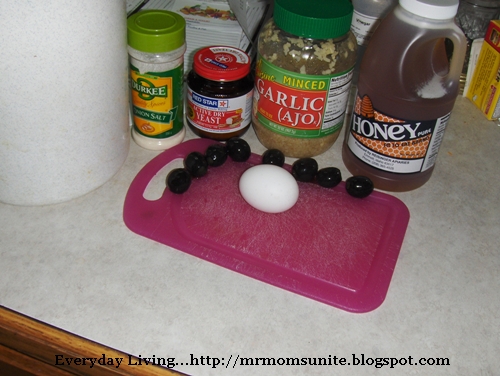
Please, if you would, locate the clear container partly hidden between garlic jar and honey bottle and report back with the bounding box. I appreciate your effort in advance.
[351,0,398,84]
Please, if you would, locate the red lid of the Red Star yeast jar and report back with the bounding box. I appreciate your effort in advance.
[193,46,250,81]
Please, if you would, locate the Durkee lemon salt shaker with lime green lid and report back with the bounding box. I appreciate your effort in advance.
[128,10,186,150]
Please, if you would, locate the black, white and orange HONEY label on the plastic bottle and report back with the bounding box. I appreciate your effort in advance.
[347,96,450,174]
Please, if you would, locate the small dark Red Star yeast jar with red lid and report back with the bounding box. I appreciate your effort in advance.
[185,46,253,141]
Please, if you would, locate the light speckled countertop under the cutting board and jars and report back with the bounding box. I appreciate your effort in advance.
[0,97,500,376]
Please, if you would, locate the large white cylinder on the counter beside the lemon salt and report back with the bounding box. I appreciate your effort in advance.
[0,0,130,205]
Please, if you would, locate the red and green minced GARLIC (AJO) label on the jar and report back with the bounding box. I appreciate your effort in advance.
[254,57,352,138]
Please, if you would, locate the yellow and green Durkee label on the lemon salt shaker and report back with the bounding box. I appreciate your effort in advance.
[130,67,183,137]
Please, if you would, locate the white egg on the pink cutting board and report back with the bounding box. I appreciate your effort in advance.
[239,164,299,213]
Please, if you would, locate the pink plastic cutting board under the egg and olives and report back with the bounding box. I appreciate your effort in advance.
[123,139,410,313]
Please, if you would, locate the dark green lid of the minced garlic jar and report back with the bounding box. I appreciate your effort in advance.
[273,0,353,39]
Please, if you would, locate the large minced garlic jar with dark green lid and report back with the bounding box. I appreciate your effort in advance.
[252,0,357,158]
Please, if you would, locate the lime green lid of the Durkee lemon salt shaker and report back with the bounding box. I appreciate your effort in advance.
[127,10,186,53]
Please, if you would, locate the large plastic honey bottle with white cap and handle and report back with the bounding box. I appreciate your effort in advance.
[342,0,466,191]
